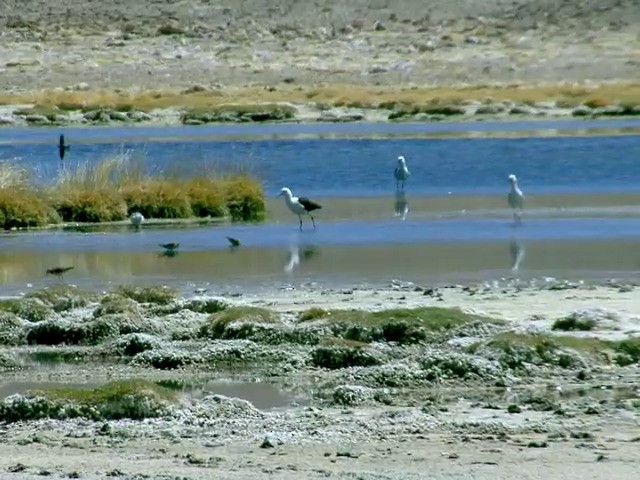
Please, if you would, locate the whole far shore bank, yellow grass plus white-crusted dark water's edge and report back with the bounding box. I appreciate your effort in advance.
[0,83,640,126]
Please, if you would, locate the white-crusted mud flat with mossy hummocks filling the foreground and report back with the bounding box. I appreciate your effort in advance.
[0,279,640,479]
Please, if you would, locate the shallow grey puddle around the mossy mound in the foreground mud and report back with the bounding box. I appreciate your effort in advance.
[0,380,304,410]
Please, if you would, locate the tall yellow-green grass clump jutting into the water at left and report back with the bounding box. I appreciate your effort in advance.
[0,154,265,229]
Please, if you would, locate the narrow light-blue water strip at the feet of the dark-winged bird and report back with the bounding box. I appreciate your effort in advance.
[0,218,640,253]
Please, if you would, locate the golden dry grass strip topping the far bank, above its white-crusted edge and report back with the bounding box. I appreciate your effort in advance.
[0,83,640,114]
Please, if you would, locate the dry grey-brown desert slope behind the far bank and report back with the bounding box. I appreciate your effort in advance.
[0,0,640,90]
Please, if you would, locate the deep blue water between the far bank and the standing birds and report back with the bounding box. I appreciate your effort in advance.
[0,121,640,198]
